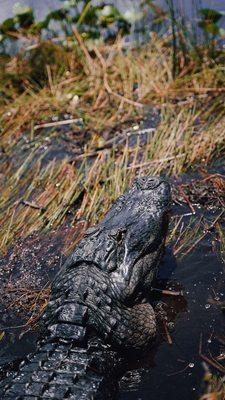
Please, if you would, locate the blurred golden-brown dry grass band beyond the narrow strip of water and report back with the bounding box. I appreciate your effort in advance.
[0,33,225,148]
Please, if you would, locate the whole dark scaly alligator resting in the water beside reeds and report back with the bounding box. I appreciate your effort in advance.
[1,176,171,400]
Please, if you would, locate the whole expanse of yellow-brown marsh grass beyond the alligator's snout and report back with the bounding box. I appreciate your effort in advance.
[0,31,225,252]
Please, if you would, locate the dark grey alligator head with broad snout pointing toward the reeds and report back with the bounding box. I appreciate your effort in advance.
[74,176,171,299]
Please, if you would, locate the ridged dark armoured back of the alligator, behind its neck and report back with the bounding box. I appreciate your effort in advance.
[0,267,117,400]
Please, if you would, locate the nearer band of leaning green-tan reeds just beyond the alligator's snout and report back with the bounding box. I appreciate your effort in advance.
[0,105,222,251]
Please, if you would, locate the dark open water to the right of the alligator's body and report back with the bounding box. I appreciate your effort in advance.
[119,227,225,400]
